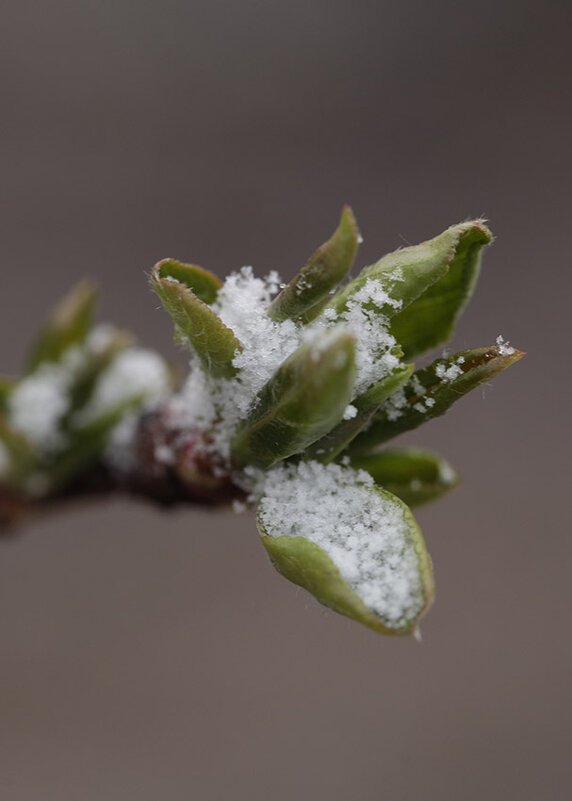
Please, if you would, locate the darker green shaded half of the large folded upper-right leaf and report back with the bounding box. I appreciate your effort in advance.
[391,223,492,359]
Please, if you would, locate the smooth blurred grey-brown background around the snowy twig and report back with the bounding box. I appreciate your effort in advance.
[0,0,572,801]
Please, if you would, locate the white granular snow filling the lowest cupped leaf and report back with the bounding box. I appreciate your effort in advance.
[260,462,425,627]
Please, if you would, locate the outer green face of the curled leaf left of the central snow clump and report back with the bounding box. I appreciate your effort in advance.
[151,262,242,378]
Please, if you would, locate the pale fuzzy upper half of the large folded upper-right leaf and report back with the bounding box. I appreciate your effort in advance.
[329,220,490,328]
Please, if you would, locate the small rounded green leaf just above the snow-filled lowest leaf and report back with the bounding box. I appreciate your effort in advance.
[351,448,459,506]
